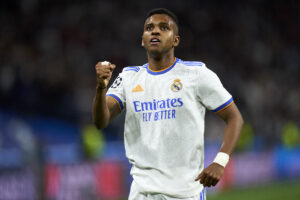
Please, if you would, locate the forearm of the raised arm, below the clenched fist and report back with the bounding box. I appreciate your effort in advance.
[93,88,110,129]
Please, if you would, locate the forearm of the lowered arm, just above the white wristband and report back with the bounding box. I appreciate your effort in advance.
[220,115,243,155]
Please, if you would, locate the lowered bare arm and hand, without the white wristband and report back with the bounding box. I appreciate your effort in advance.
[195,103,243,187]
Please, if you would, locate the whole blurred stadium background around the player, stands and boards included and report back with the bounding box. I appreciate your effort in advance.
[0,0,300,200]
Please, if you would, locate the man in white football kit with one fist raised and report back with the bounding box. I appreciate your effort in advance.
[93,9,243,200]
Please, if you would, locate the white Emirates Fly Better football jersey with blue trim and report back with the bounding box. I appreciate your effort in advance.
[107,58,233,198]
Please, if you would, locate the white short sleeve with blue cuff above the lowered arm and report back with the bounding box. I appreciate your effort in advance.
[197,66,233,112]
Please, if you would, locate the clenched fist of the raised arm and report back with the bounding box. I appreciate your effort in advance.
[95,62,116,88]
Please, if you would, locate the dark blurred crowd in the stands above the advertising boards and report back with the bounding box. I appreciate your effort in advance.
[0,0,300,145]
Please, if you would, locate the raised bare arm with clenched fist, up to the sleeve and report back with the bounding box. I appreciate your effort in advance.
[93,62,121,129]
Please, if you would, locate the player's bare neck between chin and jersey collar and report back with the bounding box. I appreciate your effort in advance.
[147,51,175,71]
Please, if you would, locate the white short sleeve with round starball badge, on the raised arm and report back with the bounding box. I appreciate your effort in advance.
[106,73,126,111]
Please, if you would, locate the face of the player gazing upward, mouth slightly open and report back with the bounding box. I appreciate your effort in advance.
[142,14,179,54]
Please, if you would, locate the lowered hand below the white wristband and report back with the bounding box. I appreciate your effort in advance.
[195,163,224,187]
